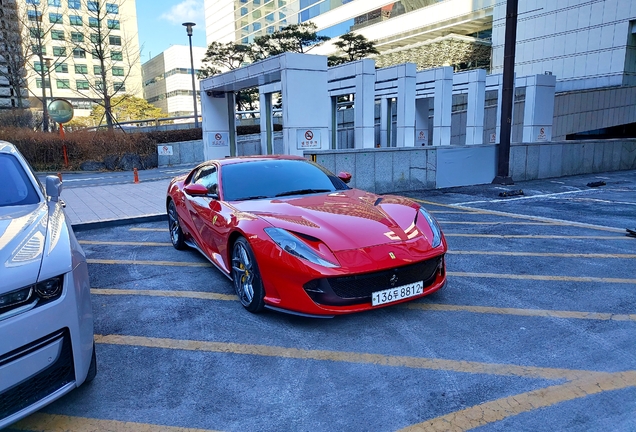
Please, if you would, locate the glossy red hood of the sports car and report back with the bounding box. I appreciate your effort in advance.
[233,189,421,252]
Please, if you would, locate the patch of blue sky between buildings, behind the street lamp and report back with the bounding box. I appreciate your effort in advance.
[136,0,206,63]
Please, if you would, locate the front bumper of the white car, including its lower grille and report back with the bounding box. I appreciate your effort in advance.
[0,262,93,429]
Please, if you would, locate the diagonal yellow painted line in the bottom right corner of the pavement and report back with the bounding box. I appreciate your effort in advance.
[401,371,636,432]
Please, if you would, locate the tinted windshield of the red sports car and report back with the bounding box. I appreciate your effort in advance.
[221,159,349,201]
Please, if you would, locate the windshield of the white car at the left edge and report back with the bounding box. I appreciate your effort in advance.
[0,154,40,207]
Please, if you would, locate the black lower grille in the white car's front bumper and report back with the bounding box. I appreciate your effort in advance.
[0,329,75,418]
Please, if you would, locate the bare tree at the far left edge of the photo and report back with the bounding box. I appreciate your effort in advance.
[0,0,27,108]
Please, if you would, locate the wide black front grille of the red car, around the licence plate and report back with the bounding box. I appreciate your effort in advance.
[304,255,444,306]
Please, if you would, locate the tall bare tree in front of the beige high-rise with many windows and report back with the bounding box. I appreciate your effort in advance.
[69,0,140,130]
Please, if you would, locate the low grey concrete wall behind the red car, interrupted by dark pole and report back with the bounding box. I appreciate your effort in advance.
[305,139,636,193]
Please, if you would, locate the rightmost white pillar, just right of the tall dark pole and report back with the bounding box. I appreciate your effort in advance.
[523,75,556,143]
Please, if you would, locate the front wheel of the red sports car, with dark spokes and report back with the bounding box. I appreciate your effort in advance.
[232,237,265,313]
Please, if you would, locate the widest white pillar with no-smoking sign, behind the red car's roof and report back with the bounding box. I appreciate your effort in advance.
[280,53,331,156]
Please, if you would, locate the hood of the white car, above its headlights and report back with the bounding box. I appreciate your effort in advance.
[0,202,49,294]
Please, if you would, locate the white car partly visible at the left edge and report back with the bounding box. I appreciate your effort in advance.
[0,141,97,429]
